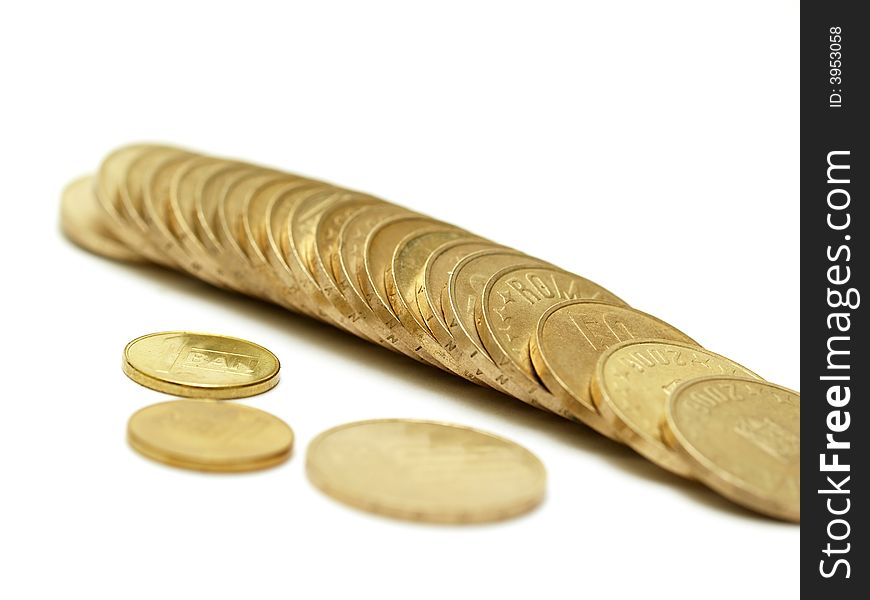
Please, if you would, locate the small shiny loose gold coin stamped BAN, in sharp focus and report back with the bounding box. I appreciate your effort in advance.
[123,331,281,400]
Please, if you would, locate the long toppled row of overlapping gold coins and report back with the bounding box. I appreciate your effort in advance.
[61,145,800,519]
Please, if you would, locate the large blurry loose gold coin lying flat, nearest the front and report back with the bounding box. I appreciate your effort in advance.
[306,419,546,523]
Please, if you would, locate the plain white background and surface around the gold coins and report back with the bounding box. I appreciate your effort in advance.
[0,0,800,599]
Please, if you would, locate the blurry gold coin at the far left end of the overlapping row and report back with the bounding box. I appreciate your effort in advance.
[60,177,143,262]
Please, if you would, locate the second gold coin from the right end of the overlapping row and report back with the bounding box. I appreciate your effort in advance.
[590,340,761,477]
